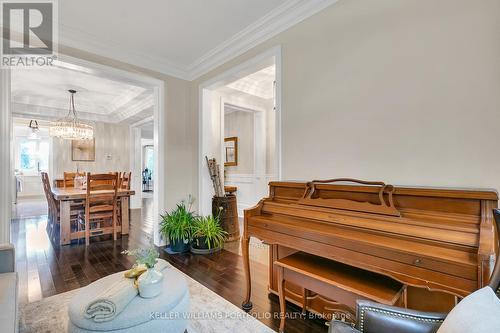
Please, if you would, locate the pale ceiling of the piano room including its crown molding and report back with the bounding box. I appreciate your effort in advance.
[58,0,336,80]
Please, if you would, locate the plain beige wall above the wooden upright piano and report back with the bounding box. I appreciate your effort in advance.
[192,0,500,195]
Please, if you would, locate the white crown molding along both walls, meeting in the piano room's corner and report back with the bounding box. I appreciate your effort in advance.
[55,0,338,81]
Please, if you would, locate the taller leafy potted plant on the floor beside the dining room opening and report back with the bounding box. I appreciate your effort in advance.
[160,196,194,253]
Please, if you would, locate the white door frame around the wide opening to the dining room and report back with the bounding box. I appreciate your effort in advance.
[0,54,167,246]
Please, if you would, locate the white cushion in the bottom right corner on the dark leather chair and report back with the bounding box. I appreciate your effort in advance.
[437,287,500,333]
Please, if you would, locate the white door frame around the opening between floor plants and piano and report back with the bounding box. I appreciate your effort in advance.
[198,45,283,214]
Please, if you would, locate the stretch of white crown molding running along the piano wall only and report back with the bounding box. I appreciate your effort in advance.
[187,0,338,80]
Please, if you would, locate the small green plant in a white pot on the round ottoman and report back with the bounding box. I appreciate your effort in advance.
[122,247,163,298]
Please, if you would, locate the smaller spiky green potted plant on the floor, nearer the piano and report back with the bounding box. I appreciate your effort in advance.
[191,215,227,254]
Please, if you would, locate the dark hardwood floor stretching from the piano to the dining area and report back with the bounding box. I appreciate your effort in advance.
[11,198,327,333]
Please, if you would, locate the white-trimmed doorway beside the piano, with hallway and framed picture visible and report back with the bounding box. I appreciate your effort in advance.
[199,47,282,217]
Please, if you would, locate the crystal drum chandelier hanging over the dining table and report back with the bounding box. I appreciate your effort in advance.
[49,90,94,140]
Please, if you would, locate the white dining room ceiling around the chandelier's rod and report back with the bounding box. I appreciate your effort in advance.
[11,67,154,124]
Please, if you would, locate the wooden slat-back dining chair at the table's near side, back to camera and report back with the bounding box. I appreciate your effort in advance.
[78,172,119,245]
